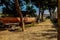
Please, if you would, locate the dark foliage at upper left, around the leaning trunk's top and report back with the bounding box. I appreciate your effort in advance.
[0,0,23,17]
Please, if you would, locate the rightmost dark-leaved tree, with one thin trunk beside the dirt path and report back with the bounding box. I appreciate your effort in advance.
[48,0,57,18]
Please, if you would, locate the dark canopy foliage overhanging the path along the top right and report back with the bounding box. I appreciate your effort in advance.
[31,0,57,9]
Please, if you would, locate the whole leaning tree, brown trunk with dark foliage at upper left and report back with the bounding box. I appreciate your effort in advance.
[0,0,24,31]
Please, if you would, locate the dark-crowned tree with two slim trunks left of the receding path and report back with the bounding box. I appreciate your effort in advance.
[31,0,48,21]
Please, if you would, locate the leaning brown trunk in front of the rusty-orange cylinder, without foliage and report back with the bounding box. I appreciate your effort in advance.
[14,0,24,31]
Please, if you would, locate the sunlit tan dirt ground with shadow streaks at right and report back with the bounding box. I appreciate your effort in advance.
[0,20,57,40]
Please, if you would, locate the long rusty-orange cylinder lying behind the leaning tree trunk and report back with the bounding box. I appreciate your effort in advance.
[0,17,36,24]
